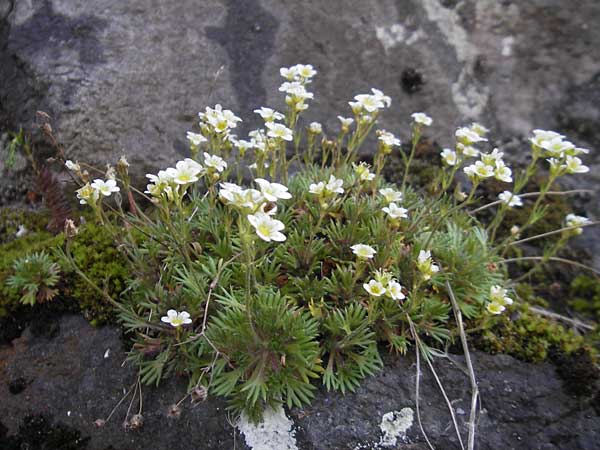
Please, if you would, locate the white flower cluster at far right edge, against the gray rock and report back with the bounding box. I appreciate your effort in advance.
[529,130,590,176]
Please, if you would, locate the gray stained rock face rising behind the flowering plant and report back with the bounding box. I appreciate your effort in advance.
[0,0,600,169]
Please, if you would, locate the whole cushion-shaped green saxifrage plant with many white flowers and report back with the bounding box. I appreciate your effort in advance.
[52,65,592,420]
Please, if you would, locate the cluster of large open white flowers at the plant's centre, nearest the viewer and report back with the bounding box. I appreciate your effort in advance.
[219,178,292,242]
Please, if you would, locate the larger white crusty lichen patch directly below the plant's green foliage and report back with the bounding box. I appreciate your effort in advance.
[237,406,298,450]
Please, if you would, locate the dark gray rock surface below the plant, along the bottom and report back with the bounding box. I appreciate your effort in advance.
[0,316,600,450]
